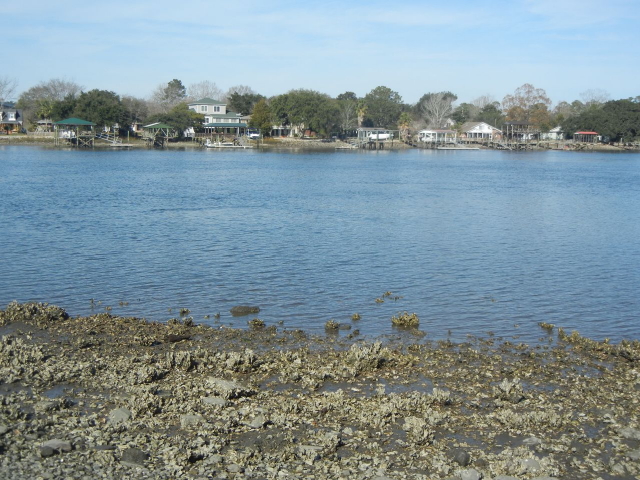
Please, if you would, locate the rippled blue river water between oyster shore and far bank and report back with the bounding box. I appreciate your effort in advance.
[0,147,640,341]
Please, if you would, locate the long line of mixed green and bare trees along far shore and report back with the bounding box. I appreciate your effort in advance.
[0,77,640,141]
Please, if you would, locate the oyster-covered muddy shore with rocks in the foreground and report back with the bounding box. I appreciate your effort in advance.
[0,303,640,480]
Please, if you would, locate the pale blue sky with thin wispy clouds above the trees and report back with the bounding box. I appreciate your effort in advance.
[0,0,640,104]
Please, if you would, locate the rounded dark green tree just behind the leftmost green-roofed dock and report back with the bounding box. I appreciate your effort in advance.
[73,89,129,128]
